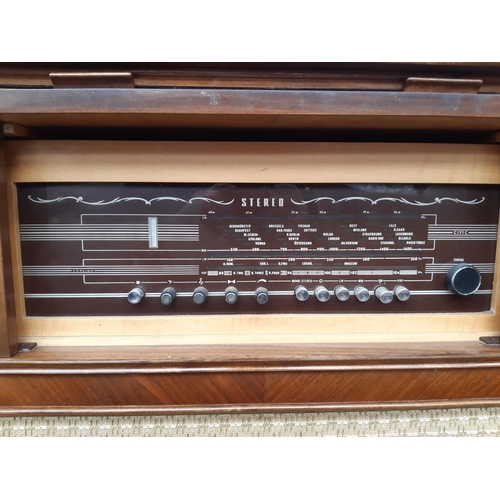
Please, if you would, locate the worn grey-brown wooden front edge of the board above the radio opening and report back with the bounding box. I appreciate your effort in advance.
[0,88,500,118]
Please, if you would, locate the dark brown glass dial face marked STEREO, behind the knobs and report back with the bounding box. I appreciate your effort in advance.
[17,183,499,316]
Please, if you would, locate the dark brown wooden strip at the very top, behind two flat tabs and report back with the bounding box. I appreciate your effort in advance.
[0,63,500,93]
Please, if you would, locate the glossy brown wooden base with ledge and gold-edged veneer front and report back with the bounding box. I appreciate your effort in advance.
[0,341,500,416]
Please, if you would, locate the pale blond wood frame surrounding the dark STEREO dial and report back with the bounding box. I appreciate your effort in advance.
[5,141,500,346]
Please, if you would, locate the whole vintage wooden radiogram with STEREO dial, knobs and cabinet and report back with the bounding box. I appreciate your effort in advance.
[0,63,500,415]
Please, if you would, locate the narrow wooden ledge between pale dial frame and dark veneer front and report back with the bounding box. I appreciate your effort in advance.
[0,340,500,367]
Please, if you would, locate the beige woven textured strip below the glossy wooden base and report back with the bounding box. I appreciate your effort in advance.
[0,408,500,437]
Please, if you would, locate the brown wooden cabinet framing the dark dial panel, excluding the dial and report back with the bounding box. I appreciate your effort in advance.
[0,64,500,415]
